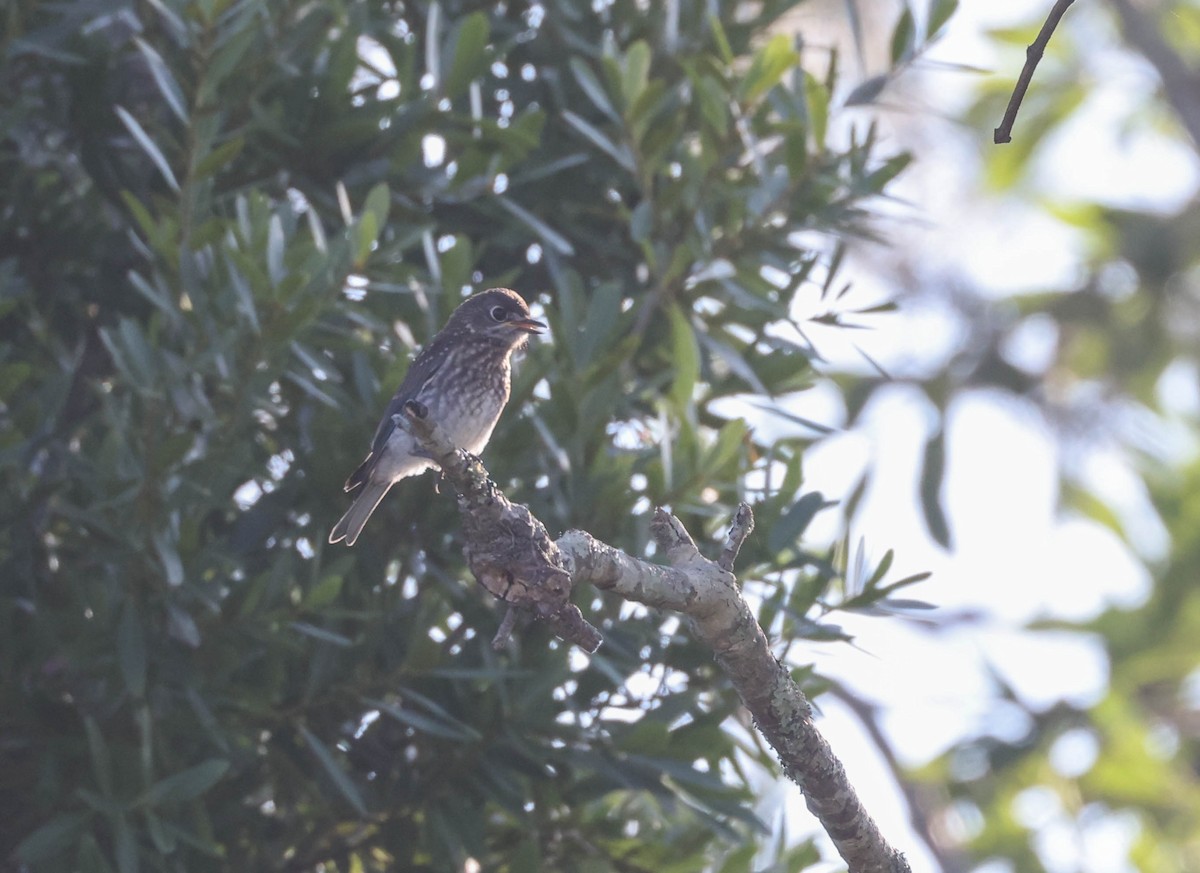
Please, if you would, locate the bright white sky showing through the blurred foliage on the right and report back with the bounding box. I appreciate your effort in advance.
[768,0,1200,873]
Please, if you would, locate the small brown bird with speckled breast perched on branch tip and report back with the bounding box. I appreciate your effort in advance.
[329,288,546,546]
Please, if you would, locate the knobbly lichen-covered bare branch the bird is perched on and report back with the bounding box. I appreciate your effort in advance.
[396,403,911,873]
